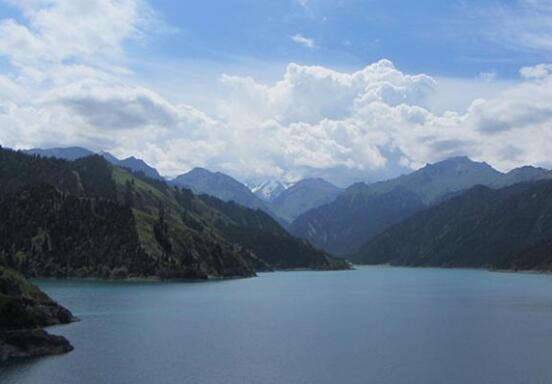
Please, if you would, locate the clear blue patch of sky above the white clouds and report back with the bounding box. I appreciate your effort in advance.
[123,0,552,109]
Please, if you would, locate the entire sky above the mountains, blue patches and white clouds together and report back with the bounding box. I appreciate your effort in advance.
[0,0,552,186]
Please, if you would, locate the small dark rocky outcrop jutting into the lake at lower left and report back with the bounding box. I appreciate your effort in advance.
[0,267,77,361]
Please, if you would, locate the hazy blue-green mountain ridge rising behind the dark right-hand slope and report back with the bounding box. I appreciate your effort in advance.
[289,157,550,256]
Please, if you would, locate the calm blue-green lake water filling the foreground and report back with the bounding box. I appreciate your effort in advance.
[0,268,552,384]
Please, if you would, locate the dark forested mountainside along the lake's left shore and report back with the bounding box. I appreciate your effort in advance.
[0,149,348,279]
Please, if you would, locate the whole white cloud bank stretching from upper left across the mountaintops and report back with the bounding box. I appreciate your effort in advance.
[0,0,552,185]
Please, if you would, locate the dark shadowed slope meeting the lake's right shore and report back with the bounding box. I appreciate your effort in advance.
[352,180,552,271]
